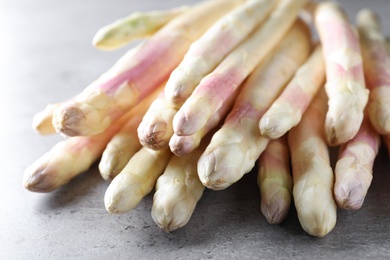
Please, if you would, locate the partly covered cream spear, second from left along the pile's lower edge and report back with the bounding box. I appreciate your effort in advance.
[99,86,163,181]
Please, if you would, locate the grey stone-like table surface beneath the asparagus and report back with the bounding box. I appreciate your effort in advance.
[0,0,390,259]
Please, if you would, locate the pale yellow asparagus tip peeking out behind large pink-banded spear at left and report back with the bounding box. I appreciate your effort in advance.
[32,103,60,135]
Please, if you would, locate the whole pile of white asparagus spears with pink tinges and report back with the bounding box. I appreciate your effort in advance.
[24,0,390,237]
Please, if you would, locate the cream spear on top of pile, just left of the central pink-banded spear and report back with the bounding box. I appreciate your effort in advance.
[165,0,278,106]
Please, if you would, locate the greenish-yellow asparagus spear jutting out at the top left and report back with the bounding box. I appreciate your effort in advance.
[92,6,189,50]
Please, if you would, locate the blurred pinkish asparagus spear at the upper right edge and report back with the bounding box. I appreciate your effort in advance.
[357,9,390,135]
